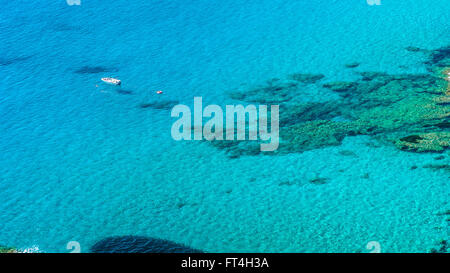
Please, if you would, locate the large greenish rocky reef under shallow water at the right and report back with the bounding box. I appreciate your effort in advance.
[211,43,450,158]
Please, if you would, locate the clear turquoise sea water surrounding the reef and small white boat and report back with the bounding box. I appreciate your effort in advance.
[0,0,450,252]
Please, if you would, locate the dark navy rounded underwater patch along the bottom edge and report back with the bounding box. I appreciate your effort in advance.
[91,236,203,253]
